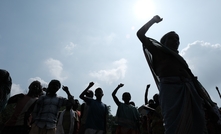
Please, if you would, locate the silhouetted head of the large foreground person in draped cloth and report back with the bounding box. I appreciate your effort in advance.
[160,31,180,52]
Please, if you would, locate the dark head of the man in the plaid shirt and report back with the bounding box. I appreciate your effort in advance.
[47,80,61,95]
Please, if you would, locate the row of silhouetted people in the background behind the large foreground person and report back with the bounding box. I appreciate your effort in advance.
[0,72,220,134]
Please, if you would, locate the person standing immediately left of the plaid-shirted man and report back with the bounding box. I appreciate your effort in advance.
[2,81,42,134]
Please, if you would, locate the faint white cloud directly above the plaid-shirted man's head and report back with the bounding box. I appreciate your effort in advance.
[45,58,67,82]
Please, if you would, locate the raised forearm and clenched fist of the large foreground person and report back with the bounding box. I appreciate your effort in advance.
[137,15,163,43]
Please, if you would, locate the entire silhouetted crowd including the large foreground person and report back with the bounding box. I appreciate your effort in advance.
[0,15,221,134]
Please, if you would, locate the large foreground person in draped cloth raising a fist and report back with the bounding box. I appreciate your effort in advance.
[137,15,221,134]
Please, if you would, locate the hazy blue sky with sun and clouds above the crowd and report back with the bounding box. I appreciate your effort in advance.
[0,0,221,115]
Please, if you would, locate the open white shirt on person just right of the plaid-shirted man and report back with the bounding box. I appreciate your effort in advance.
[56,109,75,134]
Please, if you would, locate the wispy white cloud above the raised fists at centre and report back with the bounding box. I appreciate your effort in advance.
[90,59,127,83]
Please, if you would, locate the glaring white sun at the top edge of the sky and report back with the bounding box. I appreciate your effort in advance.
[134,0,155,20]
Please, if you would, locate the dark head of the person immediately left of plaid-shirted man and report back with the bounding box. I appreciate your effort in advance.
[28,80,43,97]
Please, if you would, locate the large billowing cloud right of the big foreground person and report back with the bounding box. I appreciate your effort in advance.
[181,41,221,90]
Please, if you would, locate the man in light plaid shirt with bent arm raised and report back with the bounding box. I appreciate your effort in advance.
[30,80,74,134]
